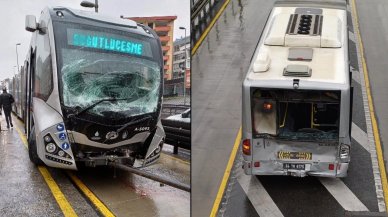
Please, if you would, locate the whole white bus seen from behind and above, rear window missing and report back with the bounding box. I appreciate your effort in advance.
[242,1,352,177]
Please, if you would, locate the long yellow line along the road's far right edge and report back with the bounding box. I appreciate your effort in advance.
[352,0,388,207]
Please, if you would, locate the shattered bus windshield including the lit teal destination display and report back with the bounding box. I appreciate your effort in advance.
[57,22,161,116]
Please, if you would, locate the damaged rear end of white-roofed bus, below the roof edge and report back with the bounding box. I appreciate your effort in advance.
[242,87,350,177]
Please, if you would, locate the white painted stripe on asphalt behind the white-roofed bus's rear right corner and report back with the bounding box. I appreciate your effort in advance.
[319,177,369,211]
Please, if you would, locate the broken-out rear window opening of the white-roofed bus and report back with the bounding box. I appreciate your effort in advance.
[252,90,340,141]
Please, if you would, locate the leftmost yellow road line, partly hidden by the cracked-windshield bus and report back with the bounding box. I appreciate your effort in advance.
[15,125,77,217]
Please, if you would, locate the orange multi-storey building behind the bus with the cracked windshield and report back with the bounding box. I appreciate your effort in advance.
[121,16,177,81]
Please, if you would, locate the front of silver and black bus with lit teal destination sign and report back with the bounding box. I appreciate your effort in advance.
[25,7,165,169]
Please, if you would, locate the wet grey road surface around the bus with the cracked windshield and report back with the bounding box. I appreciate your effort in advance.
[0,116,190,217]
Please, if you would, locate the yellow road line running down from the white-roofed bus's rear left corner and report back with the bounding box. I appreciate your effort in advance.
[210,127,241,217]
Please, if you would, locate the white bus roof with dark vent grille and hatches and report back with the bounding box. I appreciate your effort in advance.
[246,2,349,84]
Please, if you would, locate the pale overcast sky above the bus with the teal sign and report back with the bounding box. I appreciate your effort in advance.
[0,0,190,81]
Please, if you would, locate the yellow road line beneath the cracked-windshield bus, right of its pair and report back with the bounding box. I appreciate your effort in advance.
[67,171,115,217]
